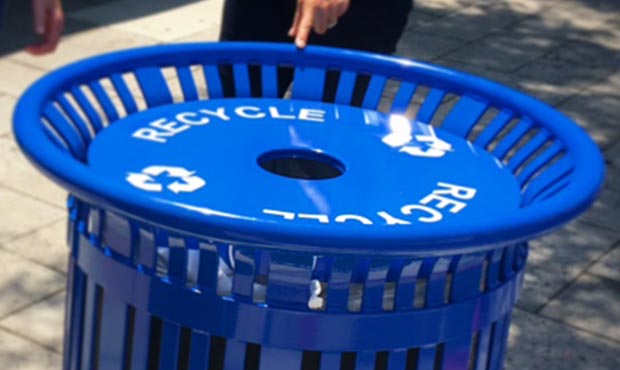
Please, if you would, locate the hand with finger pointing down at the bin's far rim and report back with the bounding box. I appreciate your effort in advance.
[288,0,350,48]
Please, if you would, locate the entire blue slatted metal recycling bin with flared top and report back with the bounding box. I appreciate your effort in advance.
[14,43,604,370]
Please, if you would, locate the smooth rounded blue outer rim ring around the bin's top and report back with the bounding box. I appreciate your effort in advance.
[14,43,604,255]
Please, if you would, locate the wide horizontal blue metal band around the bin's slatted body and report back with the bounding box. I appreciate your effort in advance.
[78,233,522,351]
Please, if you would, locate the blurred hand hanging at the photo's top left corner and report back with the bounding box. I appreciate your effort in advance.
[26,0,65,55]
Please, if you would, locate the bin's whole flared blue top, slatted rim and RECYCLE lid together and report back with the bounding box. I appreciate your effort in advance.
[14,43,604,255]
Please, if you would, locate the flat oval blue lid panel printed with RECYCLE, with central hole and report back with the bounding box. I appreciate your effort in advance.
[88,99,521,234]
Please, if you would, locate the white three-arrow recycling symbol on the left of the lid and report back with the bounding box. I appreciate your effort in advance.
[126,166,207,194]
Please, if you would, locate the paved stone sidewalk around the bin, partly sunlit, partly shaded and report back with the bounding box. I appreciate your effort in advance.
[0,0,620,370]
